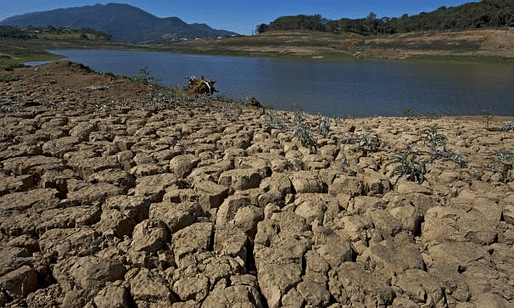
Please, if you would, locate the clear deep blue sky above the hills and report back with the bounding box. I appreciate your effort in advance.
[0,0,479,34]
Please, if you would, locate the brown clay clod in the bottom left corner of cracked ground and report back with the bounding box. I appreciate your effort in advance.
[0,265,39,298]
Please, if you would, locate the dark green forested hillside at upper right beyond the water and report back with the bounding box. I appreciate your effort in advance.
[256,0,514,35]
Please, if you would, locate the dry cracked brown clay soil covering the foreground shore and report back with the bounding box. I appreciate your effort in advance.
[0,62,514,308]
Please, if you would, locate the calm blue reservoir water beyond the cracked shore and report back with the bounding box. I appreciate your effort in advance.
[51,50,514,116]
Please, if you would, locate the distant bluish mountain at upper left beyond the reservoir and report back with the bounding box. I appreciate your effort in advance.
[0,3,239,44]
